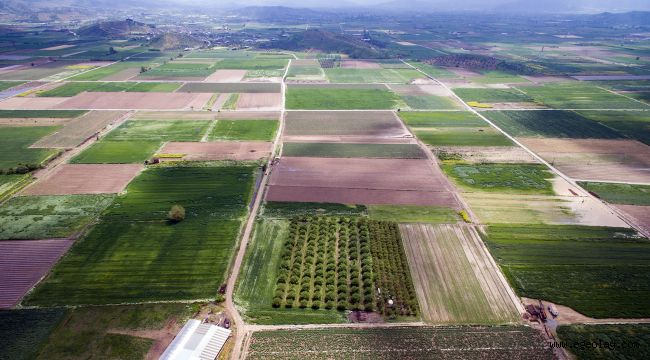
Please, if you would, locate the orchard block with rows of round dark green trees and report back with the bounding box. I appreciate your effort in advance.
[273,217,417,316]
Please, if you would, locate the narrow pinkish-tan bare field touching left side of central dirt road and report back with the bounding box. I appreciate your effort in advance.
[160,141,273,161]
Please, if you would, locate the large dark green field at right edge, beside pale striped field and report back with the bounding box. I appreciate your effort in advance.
[485,225,650,318]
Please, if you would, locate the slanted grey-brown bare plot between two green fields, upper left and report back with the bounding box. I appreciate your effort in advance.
[31,111,127,149]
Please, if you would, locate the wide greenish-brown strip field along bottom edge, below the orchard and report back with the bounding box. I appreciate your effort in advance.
[247,326,555,360]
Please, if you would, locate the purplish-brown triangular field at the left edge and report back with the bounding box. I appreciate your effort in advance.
[0,239,74,309]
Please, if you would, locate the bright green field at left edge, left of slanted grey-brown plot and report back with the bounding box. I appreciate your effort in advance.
[0,126,60,171]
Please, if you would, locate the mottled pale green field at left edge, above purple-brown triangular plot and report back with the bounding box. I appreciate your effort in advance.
[0,194,114,240]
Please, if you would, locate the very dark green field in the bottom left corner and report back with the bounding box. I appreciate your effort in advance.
[0,309,66,360]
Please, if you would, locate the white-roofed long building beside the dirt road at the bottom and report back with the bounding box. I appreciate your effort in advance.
[160,320,231,360]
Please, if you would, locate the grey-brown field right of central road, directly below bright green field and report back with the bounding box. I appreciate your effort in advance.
[284,111,411,137]
